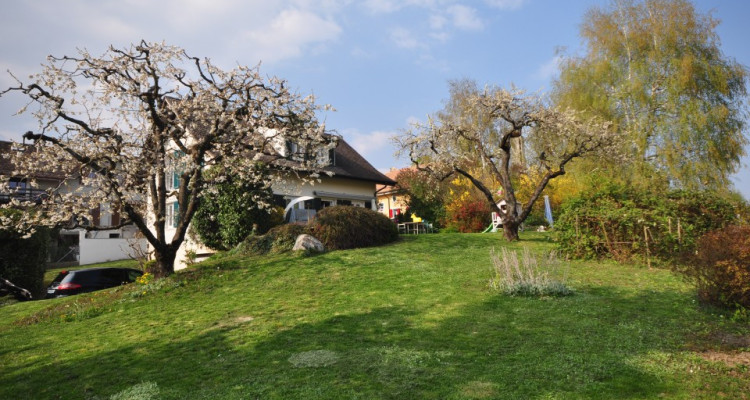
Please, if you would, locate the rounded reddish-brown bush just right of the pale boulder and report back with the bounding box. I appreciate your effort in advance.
[310,206,398,250]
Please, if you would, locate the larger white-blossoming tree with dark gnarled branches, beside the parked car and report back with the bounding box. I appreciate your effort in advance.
[0,41,331,275]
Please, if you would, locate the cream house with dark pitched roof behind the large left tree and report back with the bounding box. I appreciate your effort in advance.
[166,138,396,269]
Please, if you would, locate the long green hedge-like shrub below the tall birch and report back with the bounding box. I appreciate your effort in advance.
[555,182,737,262]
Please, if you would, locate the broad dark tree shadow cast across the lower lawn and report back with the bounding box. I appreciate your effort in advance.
[0,288,704,399]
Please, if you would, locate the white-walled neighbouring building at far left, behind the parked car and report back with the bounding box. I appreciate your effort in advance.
[0,141,147,265]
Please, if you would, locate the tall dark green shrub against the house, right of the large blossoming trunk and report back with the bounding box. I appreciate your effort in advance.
[191,168,283,250]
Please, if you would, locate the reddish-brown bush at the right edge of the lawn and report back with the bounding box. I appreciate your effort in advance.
[676,226,750,308]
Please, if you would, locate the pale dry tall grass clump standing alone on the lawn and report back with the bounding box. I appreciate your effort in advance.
[490,247,573,297]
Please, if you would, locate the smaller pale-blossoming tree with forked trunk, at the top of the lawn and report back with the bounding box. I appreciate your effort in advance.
[396,80,620,240]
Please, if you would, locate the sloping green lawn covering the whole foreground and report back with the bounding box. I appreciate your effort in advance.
[0,233,750,399]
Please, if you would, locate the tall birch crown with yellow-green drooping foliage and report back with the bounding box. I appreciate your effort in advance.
[555,0,748,189]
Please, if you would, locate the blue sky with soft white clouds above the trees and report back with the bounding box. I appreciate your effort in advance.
[0,0,750,199]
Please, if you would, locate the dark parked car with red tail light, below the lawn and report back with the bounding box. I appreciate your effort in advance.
[46,268,143,299]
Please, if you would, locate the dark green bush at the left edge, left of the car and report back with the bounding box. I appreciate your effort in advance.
[0,222,50,299]
